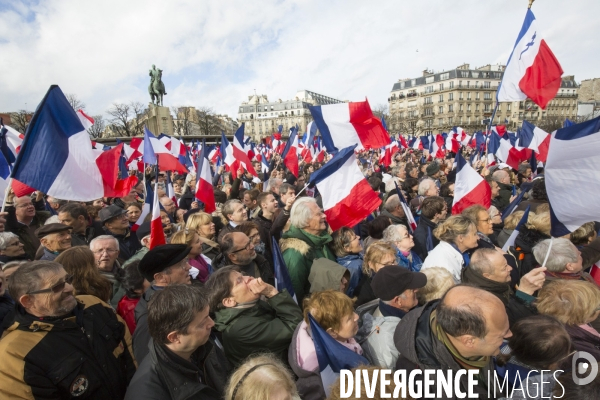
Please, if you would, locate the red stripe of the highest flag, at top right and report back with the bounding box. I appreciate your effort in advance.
[519,39,563,110]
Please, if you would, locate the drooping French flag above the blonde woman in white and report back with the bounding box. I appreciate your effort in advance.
[452,153,492,214]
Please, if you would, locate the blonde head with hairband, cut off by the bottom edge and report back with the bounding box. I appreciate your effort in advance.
[225,354,300,400]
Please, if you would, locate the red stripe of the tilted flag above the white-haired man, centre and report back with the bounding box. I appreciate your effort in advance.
[325,179,381,231]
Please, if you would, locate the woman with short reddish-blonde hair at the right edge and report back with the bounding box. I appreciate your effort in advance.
[536,279,600,360]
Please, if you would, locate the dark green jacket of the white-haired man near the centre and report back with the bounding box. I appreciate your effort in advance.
[280,225,335,304]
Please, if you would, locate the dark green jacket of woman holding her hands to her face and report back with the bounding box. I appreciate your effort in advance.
[215,291,302,366]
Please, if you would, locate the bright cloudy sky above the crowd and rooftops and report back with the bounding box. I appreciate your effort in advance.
[0,0,600,118]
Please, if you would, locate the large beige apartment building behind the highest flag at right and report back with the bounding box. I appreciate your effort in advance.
[387,64,578,135]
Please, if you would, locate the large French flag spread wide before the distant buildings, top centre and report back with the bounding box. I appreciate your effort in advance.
[309,100,390,153]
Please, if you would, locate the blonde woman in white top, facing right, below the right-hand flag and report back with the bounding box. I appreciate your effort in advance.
[421,215,478,283]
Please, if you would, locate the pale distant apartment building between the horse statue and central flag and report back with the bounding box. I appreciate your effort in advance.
[238,90,343,142]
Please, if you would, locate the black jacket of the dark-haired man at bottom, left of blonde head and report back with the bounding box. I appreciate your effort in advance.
[125,339,231,400]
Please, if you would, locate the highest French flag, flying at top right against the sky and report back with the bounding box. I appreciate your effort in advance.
[496,9,563,109]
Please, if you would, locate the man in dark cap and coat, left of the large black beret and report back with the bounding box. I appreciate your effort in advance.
[98,204,142,261]
